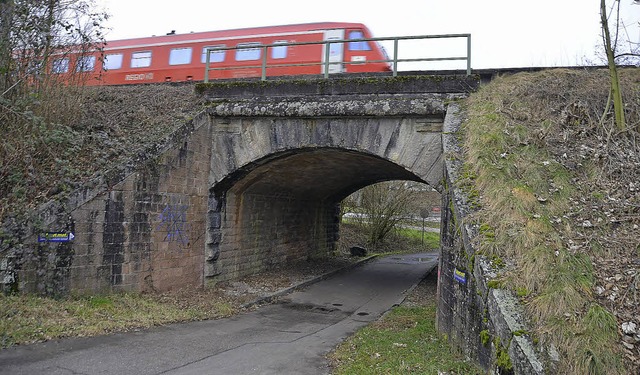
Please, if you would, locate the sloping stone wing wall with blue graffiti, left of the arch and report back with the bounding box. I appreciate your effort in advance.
[0,116,211,295]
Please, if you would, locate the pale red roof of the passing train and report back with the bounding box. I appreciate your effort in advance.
[105,22,366,50]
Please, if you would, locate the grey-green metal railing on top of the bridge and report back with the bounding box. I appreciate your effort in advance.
[204,34,471,82]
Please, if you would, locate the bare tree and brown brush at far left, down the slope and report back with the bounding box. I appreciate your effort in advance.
[0,0,106,221]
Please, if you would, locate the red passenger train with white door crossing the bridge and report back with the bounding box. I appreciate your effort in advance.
[51,22,391,85]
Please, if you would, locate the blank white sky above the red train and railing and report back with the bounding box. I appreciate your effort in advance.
[97,0,640,69]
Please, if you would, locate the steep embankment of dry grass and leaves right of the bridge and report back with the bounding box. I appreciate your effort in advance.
[460,70,640,374]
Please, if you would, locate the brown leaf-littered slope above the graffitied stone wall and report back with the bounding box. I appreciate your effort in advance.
[0,84,203,223]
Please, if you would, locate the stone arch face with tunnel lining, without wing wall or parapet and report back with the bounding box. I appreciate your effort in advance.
[204,106,443,283]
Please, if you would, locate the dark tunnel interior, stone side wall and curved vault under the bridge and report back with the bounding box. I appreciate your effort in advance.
[205,148,437,282]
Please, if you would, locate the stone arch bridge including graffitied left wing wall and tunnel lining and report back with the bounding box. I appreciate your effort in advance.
[0,75,478,293]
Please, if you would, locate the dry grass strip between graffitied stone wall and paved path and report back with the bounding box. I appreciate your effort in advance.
[0,292,235,348]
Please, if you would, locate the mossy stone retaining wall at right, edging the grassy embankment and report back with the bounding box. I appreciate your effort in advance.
[437,105,550,374]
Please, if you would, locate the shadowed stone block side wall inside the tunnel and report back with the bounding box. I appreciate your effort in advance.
[205,193,337,284]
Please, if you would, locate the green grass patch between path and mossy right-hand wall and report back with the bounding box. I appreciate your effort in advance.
[330,305,484,375]
